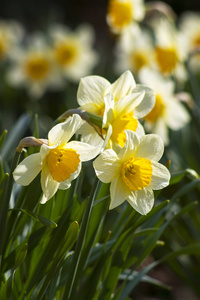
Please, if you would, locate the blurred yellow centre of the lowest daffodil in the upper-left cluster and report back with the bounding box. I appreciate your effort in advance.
[25,54,50,80]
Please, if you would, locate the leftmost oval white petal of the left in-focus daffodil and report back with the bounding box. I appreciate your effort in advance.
[13,153,42,186]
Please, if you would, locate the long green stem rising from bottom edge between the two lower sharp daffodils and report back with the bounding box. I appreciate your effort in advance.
[63,177,99,300]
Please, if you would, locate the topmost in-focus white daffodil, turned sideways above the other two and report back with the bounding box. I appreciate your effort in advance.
[77,71,155,148]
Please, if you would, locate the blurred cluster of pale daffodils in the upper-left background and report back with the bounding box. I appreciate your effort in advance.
[0,20,98,99]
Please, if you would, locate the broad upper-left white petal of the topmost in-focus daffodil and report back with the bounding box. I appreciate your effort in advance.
[77,76,110,105]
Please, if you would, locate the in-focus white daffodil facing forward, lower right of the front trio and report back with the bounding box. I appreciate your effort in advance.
[93,130,170,215]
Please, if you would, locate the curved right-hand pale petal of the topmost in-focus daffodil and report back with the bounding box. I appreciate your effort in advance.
[134,85,155,119]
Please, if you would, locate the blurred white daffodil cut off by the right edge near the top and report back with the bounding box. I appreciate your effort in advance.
[180,12,200,72]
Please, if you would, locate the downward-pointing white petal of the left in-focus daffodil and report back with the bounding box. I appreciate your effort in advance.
[40,166,59,203]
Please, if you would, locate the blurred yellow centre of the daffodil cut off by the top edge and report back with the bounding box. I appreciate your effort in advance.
[108,0,132,28]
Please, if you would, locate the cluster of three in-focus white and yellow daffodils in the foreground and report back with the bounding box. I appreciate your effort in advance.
[13,71,170,214]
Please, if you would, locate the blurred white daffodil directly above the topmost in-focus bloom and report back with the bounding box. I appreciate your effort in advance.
[115,25,155,74]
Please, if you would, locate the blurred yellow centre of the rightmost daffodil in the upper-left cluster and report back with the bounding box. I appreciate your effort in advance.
[55,41,77,66]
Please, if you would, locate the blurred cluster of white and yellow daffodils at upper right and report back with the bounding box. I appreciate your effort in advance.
[107,0,200,145]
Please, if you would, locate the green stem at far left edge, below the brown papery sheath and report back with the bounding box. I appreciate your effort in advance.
[0,151,21,272]
